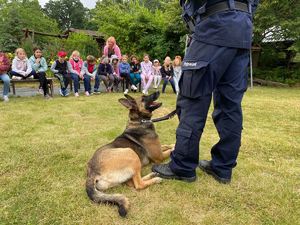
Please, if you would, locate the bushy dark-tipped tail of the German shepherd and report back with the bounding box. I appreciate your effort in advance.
[86,177,129,217]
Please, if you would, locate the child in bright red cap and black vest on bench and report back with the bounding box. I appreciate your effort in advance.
[50,51,73,96]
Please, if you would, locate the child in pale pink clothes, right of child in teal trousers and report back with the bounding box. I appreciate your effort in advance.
[141,54,153,94]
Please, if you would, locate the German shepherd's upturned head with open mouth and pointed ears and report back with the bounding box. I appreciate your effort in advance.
[119,91,162,119]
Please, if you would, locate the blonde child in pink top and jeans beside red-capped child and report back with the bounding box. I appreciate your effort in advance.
[69,50,83,97]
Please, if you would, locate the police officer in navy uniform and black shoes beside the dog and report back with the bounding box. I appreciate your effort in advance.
[152,0,258,183]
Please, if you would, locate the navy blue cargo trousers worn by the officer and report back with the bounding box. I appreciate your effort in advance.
[169,40,249,178]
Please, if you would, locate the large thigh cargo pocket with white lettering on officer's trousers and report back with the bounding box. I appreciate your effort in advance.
[179,61,208,98]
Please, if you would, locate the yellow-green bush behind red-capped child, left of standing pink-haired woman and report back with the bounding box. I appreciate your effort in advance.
[64,33,100,59]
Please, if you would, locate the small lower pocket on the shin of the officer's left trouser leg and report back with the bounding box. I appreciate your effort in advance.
[176,128,192,155]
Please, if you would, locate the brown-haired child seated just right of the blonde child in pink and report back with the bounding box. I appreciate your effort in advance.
[81,55,100,96]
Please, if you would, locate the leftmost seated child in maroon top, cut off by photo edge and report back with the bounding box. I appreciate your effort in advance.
[0,52,10,102]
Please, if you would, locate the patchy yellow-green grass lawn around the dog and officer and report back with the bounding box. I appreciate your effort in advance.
[0,87,300,225]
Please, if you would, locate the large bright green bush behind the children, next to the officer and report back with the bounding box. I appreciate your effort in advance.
[92,0,184,59]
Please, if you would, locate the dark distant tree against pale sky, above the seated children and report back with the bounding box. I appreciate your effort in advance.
[44,0,89,30]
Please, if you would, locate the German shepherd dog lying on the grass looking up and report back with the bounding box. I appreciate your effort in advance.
[86,92,174,217]
